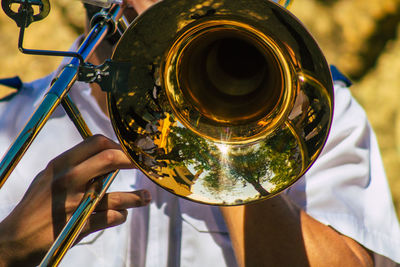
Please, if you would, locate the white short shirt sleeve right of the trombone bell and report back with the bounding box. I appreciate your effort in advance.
[287,82,400,262]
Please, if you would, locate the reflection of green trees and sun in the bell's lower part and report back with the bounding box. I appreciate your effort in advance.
[159,126,302,199]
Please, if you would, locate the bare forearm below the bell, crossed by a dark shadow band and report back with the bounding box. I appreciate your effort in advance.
[221,195,373,266]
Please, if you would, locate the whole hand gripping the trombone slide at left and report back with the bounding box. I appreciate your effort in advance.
[0,135,150,266]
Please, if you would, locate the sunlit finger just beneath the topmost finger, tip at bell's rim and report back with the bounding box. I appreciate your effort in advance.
[63,149,135,189]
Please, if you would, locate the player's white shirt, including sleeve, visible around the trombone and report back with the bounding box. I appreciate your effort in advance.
[0,70,400,267]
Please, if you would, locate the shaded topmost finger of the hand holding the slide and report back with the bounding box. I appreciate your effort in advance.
[50,135,121,170]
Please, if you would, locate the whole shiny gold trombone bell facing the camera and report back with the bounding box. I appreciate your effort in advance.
[108,0,333,205]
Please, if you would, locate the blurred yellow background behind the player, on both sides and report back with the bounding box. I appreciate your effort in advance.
[0,0,400,218]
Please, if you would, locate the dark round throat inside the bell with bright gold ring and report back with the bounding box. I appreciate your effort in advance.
[163,20,292,143]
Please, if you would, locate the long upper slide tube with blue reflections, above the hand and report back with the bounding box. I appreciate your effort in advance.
[0,5,121,188]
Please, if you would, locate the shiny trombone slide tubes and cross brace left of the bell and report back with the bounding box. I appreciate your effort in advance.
[0,3,121,266]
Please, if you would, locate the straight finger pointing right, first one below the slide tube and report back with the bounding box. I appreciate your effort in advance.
[96,190,151,211]
